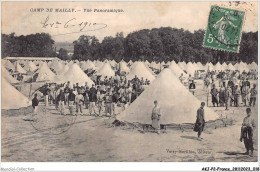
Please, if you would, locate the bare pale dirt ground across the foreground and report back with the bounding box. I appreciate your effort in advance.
[1,81,258,162]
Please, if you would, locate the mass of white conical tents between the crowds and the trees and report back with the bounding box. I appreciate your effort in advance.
[2,60,257,86]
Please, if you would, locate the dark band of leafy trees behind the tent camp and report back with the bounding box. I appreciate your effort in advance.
[2,27,258,64]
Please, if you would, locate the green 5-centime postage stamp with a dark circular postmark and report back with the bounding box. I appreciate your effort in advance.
[203,6,245,53]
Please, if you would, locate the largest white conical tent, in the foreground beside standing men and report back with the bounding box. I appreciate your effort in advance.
[117,68,219,124]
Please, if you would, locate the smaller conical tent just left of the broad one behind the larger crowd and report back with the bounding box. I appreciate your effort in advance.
[34,62,55,81]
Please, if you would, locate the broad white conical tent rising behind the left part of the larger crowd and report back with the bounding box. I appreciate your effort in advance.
[53,63,94,87]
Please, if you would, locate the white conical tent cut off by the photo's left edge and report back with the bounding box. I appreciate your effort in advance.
[1,78,30,109]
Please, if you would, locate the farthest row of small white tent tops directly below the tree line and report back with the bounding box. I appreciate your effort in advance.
[2,60,257,73]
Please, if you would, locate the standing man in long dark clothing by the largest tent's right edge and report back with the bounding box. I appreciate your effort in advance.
[194,102,205,141]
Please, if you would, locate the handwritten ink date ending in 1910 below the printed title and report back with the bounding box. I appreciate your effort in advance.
[41,16,107,34]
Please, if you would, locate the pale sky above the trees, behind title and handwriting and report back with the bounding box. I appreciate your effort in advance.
[2,2,258,42]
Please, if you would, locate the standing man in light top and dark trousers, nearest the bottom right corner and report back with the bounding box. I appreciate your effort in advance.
[240,108,256,156]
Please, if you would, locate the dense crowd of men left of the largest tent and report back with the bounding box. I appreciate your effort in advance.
[37,75,150,116]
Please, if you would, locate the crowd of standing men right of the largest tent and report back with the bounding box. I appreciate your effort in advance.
[204,72,257,110]
